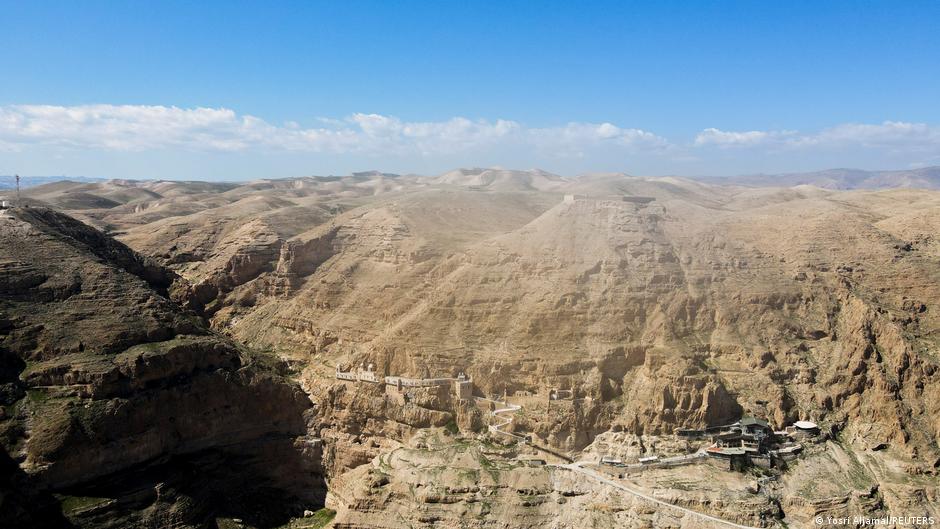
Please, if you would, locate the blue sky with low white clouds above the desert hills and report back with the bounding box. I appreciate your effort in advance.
[0,1,940,179]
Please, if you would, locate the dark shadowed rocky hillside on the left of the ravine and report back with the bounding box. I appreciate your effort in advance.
[0,208,325,528]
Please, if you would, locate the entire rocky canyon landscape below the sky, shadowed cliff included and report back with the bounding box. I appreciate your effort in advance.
[0,169,940,528]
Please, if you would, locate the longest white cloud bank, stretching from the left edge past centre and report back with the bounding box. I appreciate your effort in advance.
[0,105,668,155]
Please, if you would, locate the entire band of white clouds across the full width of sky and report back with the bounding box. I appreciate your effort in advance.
[0,105,940,167]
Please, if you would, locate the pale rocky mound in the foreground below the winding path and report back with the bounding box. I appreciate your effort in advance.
[327,442,776,529]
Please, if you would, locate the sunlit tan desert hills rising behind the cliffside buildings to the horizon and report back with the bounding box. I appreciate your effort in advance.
[7,169,940,526]
